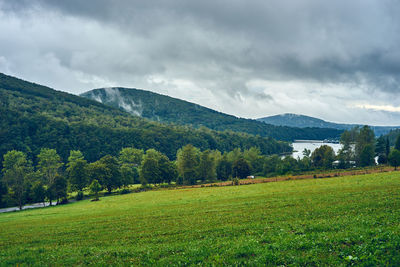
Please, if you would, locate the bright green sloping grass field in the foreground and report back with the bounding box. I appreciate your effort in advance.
[0,172,400,266]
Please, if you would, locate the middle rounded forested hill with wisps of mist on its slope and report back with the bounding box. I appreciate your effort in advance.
[81,87,342,141]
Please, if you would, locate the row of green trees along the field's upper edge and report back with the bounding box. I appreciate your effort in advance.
[0,126,400,211]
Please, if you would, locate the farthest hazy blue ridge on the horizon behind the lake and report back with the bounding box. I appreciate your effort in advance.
[257,113,400,136]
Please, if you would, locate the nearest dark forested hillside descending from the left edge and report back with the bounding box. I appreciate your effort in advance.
[0,73,291,167]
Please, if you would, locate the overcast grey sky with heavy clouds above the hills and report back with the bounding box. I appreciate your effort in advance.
[0,0,400,125]
